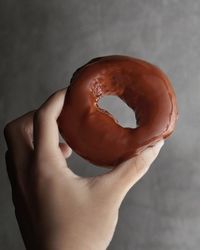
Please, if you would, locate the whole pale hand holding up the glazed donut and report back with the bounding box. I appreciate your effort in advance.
[4,89,164,250]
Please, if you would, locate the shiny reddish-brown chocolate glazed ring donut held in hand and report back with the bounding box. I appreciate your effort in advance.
[58,55,177,167]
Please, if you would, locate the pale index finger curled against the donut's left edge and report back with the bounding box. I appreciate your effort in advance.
[34,89,66,158]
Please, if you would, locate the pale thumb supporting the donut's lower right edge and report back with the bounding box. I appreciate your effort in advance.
[97,140,164,204]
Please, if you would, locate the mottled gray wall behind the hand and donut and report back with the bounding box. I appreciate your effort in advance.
[0,0,200,250]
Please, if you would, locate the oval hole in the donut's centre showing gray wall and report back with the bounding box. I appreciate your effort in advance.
[98,95,136,128]
